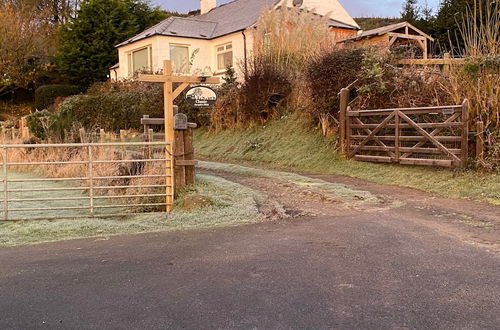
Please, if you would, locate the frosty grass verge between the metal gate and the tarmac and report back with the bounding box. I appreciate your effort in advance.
[0,175,265,246]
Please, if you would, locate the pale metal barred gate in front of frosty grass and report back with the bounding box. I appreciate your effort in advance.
[0,142,174,221]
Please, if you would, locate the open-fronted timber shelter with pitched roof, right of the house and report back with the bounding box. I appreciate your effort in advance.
[338,22,434,59]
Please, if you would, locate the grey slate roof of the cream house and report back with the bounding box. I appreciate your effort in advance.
[116,0,358,47]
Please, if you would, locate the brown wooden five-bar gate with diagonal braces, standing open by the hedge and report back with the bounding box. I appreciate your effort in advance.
[340,93,469,167]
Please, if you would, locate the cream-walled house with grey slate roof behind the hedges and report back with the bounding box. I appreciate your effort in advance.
[110,0,360,80]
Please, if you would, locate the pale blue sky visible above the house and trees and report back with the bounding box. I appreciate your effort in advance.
[150,0,440,17]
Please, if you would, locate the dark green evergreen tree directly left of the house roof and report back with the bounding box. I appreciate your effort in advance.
[56,0,167,86]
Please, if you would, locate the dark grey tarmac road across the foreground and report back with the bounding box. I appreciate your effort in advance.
[0,211,500,329]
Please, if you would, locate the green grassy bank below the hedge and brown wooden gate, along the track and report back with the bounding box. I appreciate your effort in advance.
[195,117,500,205]
